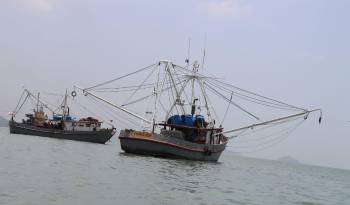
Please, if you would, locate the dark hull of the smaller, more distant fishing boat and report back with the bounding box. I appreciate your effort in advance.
[9,121,115,144]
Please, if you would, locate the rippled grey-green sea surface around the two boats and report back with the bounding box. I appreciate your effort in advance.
[0,128,350,205]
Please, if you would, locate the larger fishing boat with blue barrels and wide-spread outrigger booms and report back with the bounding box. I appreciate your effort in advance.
[76,60,320,161]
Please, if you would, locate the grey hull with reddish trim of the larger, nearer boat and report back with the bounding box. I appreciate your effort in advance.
[119,130,226,162]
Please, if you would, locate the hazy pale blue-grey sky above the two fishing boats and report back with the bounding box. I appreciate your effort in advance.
[0,0,350,169]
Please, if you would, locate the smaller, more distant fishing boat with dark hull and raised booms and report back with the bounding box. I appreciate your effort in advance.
[9,89,116,144]
